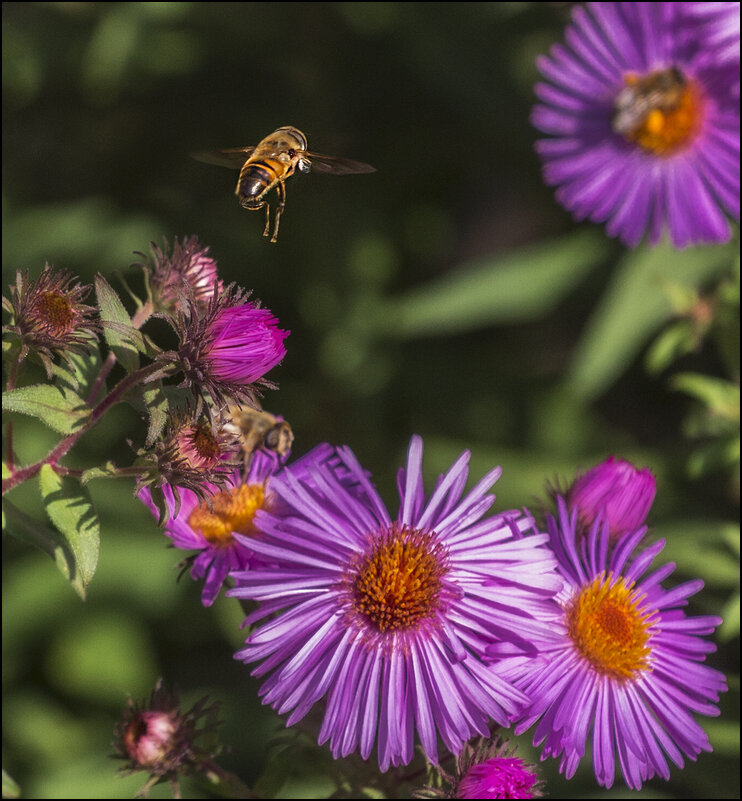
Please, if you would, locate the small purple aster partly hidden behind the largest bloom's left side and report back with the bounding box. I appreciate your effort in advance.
[138,445,334,606]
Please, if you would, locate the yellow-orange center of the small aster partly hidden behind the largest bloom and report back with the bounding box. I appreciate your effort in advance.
[188,484,265,547]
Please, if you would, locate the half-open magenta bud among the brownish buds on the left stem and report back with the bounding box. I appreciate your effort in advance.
[206,303,289,384]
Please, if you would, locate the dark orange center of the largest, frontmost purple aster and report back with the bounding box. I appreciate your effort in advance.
[352,523,448,632]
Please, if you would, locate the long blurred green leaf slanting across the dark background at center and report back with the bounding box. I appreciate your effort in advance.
[378,231,606,338]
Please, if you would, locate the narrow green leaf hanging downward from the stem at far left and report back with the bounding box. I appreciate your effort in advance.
[39,464,100,598]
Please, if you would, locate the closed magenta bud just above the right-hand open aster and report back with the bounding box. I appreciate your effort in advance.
[567,456,657,543]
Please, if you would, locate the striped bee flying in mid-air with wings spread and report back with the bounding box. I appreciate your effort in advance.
[195,125,376,242]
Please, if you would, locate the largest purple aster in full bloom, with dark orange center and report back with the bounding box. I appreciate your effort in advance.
[229,436,561,771]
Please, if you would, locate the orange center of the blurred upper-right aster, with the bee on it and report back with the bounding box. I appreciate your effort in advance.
[613,67,703,156]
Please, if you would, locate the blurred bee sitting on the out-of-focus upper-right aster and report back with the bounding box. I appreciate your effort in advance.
[612,67,687,135]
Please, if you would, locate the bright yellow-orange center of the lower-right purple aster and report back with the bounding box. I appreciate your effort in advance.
[567,574,651,681]
